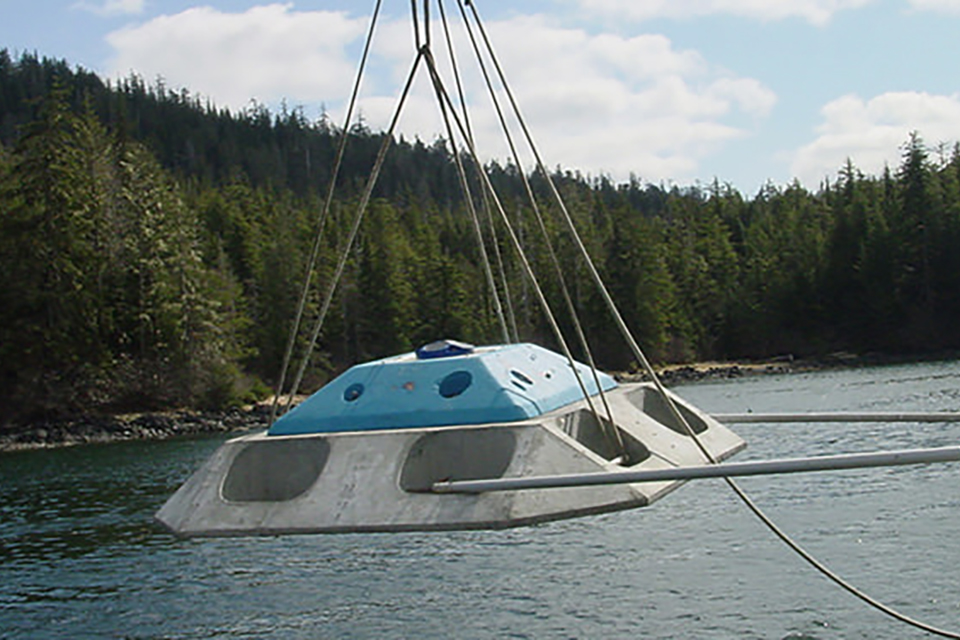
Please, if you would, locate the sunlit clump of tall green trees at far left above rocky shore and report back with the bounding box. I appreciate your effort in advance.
[0,76,247,414]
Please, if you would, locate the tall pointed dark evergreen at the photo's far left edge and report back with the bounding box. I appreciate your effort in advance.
[0,79,102,416]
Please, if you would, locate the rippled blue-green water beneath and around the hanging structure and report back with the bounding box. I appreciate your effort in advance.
[0,363,960,640]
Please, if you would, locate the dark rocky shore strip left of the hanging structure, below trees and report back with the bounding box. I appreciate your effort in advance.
[0,405,270,451]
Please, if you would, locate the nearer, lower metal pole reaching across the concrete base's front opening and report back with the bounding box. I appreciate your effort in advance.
[433,446,960,493]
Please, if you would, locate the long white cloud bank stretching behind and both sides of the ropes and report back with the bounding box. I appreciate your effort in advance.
[109,4,776,183]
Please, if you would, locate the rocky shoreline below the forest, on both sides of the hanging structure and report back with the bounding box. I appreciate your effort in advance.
[0,352,960,453]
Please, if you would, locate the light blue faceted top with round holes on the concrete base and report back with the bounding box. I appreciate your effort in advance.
[269,341,617,435]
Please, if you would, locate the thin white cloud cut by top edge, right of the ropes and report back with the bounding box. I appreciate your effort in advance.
[577,0,876,25]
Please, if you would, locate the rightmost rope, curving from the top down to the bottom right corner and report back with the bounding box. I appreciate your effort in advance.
[459,0,960,640]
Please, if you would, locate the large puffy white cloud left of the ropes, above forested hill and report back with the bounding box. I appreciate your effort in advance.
[107,4,366,109]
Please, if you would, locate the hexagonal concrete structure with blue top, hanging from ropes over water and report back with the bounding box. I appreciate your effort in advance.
[157,342,745,536]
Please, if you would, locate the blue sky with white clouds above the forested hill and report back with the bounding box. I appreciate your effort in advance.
[0,0,960,197]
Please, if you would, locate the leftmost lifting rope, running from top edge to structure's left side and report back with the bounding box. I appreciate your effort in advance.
[267,0,383,428]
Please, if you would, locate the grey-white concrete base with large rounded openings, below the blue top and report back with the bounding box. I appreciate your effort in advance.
[157,384,745,536]
